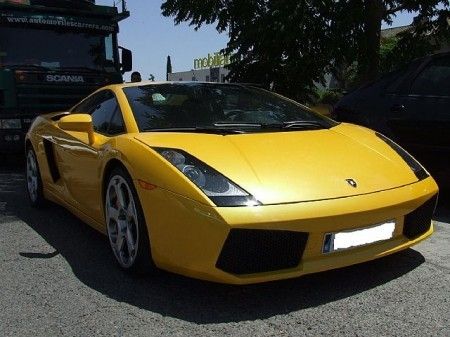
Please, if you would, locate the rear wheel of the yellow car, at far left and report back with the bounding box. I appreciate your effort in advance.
[26,146,46,208]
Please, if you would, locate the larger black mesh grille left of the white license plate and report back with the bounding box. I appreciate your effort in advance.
[216,229,308,274]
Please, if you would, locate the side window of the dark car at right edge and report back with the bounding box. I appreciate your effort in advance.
[410,57,450,96]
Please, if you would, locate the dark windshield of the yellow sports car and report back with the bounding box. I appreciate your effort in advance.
[123,83,336,133]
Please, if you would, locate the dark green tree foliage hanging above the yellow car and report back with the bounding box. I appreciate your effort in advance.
[161,0,449,100]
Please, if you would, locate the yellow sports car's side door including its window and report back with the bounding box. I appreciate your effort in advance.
[56,90,125,222]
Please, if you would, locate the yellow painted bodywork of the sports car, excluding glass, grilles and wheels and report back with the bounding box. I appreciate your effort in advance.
[27,84,438,284]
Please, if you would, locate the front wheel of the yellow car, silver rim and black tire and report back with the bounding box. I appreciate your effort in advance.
[104,167,155,274]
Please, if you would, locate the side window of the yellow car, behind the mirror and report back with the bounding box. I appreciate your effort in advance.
[72,90,125,135]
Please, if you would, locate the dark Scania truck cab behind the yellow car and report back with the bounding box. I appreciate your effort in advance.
[0,0,131,153]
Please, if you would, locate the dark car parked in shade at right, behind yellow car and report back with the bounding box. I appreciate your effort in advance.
[333,52,450,185]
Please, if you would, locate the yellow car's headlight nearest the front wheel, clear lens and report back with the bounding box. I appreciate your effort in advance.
[153,148,260,206]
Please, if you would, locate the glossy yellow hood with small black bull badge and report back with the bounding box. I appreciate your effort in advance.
[135,123,417,204]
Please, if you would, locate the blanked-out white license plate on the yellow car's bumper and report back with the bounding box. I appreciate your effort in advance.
[322,220,395,253]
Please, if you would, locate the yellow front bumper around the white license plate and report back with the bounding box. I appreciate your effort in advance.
[137,177,438,284]
